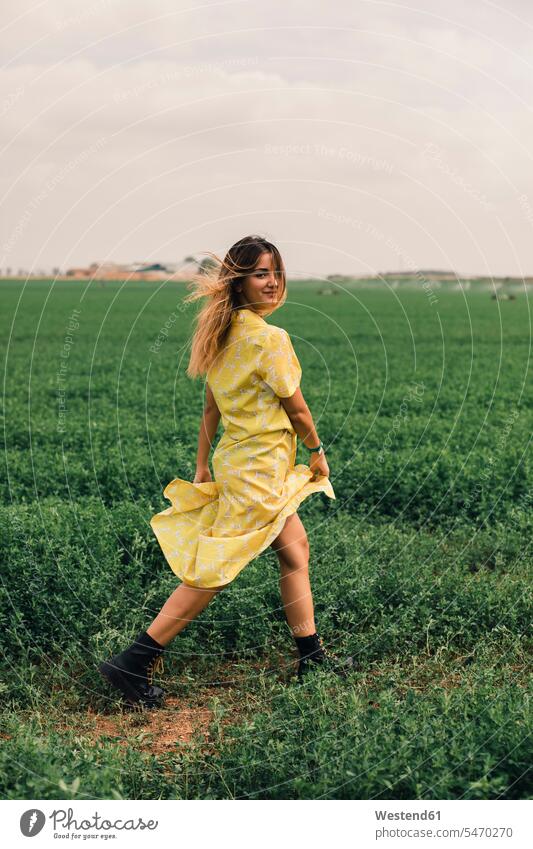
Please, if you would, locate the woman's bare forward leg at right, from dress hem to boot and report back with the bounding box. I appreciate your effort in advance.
[271,513,316,637]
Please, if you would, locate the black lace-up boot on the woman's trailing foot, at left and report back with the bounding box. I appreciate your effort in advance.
[98,631,165,709]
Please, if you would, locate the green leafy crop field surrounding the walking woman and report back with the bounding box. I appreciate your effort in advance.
[0,281,533,799]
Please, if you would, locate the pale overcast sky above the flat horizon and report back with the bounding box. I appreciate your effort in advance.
[0,0,533,276]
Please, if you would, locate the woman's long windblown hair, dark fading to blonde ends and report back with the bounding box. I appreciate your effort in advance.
[184,236,287,377]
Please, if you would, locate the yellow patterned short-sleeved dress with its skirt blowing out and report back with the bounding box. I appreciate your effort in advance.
[150,308,335,588]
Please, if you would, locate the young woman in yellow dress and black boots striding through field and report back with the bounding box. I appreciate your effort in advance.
[99,236,353,708]
